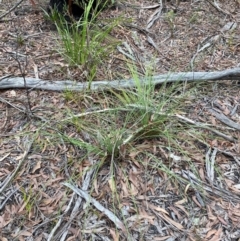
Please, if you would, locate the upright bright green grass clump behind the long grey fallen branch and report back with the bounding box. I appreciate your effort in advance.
[46,0,119,83]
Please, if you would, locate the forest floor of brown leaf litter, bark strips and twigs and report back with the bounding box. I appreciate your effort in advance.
[0,0,240,241]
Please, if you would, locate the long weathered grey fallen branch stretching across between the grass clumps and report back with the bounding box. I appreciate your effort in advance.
[0,68,240,91]
